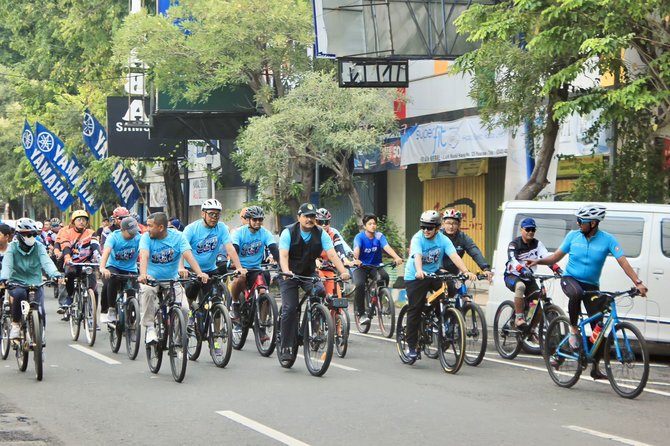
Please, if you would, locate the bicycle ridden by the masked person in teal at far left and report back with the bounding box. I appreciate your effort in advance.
[7,280,53,381]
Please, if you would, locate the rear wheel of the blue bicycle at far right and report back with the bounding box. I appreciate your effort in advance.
[544,316,583,387]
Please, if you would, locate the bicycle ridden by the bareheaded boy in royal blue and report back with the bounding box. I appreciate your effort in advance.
[354,262,395,338]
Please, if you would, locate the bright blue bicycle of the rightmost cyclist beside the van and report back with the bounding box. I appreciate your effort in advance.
[544,288,649,399]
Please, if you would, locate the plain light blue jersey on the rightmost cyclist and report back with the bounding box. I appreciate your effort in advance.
[558,229,624,287]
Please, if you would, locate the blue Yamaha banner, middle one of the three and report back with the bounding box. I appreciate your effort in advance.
[35,122,100,215]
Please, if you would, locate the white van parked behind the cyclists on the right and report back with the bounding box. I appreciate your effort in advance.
[486,201,670,354]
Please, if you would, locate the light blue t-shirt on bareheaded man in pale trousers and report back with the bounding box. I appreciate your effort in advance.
[140,228,191,280]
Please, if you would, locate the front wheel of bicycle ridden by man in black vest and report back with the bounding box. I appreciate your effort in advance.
[302,304,334,376]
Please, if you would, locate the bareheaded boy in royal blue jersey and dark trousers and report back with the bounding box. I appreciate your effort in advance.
[354,214,402,324]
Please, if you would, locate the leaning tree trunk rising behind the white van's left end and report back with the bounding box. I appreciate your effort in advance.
[515,89,568,200]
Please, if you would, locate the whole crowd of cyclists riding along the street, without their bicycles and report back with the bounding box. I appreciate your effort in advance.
[0,199,647,386]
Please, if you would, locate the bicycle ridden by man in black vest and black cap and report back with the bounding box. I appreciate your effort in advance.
[277,273,340,376]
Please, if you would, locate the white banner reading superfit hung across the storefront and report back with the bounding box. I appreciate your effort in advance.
[400,116,509,166]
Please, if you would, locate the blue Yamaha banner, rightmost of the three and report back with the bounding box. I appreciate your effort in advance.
[83,109,141,209]
